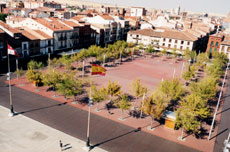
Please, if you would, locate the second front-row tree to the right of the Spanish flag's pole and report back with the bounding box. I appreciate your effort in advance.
[115,94,131,120]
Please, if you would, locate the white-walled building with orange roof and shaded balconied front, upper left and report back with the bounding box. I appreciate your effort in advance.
[7,18,79,52]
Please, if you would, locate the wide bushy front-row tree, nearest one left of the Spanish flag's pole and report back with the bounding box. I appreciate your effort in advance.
[57,74,83,98]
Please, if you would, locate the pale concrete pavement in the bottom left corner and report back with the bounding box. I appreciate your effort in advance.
[0,106,105,152]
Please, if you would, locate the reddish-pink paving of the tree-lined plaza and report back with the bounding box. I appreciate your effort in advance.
[8,57,225,152]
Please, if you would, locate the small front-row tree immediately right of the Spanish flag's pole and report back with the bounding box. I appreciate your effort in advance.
[92,86,107,111]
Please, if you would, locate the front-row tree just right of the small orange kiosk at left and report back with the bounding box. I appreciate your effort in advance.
[42,70,62,96]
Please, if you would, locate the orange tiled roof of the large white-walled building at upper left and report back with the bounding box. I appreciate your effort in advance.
[33,18,71,31]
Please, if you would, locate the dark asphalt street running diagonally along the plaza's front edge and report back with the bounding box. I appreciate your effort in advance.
[0,76,196,152]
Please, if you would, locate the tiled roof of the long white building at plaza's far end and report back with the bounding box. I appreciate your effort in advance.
[129,29,197,41]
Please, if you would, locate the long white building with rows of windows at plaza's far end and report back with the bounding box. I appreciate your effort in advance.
[127,29,197,51]
